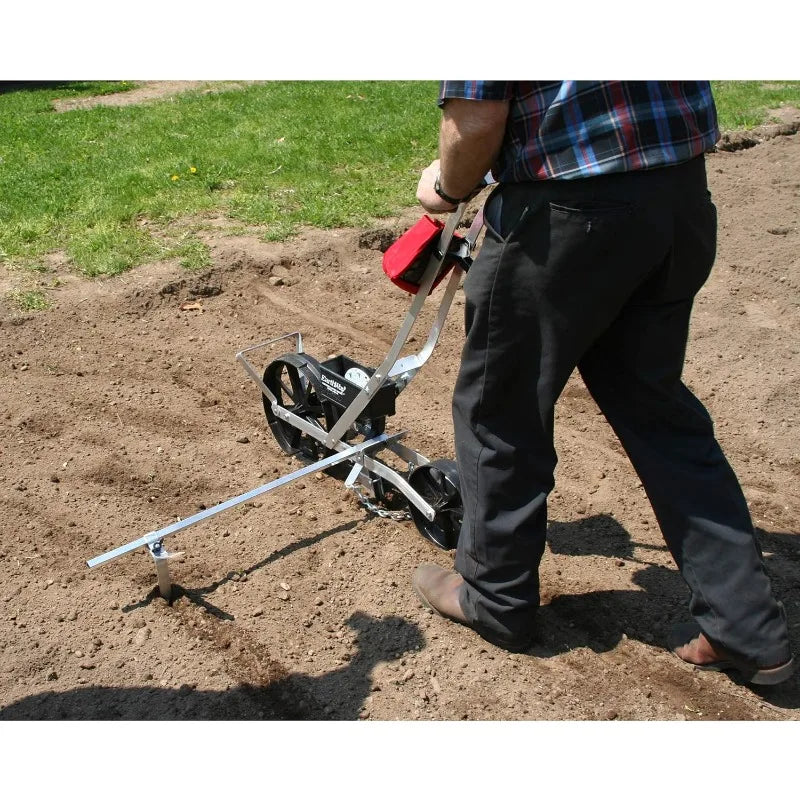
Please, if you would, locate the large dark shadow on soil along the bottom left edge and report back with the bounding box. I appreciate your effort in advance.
[0,612,425,721]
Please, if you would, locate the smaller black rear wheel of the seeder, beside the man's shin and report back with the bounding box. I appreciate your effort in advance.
[408,458,464,550]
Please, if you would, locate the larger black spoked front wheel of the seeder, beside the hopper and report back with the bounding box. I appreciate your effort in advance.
[262,353,332,461]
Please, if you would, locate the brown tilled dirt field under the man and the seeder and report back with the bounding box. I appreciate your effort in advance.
[0,114,800,720]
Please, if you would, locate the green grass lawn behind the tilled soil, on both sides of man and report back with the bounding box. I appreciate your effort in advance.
[0,81,800,290]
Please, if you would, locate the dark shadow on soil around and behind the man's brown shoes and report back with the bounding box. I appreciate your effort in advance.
[528,515,800,708]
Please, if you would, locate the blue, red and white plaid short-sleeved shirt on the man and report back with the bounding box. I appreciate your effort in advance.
[439,81,719,182]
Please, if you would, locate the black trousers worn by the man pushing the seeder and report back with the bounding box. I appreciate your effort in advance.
[453,158,790,665]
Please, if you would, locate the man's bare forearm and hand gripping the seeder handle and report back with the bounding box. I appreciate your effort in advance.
[417,98,509,214]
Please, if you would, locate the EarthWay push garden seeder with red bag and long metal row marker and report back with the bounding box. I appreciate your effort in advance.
[86,203,483,598]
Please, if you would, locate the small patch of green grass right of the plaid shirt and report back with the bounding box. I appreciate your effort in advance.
[712,81,800,131]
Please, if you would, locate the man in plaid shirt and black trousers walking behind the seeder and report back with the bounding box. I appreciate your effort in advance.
[413,81,794,683]
